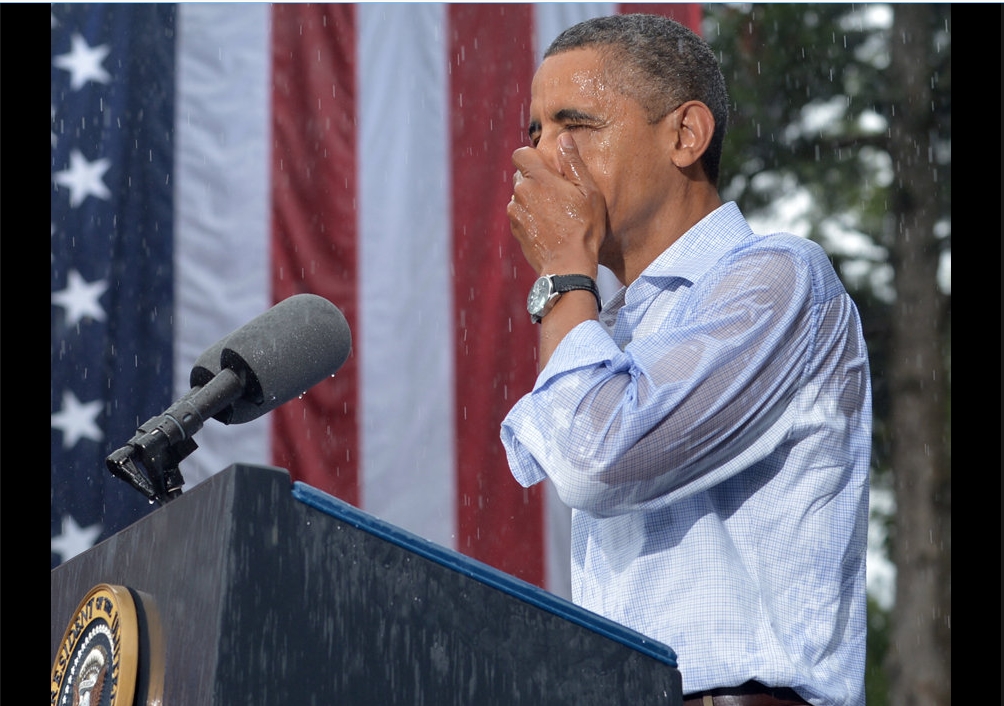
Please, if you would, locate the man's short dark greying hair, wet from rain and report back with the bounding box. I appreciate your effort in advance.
[544,14,729,186]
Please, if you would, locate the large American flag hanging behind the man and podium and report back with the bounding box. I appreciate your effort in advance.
[50,3,701,595]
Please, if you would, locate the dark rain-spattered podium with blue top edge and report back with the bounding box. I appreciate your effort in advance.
[50,465,681,706]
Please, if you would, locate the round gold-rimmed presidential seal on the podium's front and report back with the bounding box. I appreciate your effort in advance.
[49,583,140,706]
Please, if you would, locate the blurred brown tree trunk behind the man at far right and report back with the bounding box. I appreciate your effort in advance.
[888,4,952,706]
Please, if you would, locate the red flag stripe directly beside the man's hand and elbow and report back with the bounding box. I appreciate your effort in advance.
[449,4,544,585]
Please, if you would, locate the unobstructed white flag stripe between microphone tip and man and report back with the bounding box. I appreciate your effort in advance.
[354,3,457,547]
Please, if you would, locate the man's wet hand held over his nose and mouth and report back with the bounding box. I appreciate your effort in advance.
[507,133,606,278]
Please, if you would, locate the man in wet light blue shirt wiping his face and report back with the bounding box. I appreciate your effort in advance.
[502,15,871,706]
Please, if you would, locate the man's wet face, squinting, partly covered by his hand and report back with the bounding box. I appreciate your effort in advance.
[529,49,674,254]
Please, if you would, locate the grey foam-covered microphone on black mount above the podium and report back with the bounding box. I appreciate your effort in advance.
[105,294,351,504]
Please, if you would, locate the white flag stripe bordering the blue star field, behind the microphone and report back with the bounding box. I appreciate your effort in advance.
[175,3,272,490]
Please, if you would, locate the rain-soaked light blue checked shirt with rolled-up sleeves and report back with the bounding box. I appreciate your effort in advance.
[501,203,871,704]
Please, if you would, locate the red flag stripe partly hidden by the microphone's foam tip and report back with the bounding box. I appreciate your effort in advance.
[272,3,359,505]
